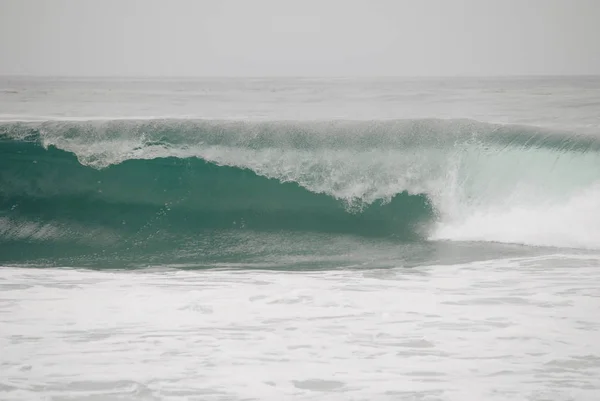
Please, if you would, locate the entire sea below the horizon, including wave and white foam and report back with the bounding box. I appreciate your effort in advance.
[0,77,600,401]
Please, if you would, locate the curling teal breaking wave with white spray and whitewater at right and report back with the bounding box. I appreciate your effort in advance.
[0,120,600,262]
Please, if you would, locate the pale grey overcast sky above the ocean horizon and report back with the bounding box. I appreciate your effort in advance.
[0,0,600,76]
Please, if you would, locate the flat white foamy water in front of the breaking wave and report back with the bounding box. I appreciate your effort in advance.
[0,255,600,401]
